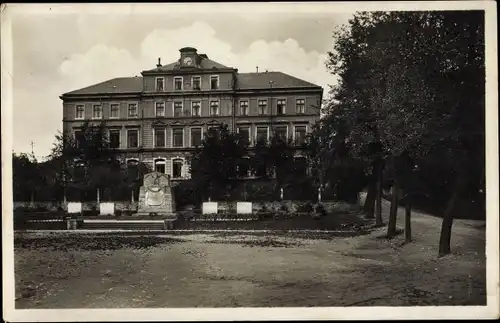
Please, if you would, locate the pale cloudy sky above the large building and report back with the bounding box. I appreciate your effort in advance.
[5,4,352,158]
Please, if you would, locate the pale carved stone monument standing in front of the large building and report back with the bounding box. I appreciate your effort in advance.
[135,172,176,219]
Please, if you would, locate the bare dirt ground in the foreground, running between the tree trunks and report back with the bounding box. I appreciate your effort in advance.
[15,200,486,309]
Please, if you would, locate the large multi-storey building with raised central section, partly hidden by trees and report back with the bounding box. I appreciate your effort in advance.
[60,47,323,180]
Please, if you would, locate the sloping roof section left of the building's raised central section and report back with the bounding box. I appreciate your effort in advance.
[63,76,142,95]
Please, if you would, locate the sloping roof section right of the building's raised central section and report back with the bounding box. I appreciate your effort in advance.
[237,72,320,90]
